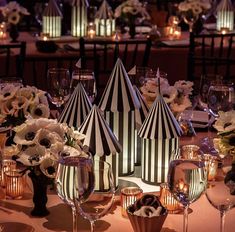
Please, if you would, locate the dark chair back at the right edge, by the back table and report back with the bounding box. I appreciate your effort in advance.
[188,33,235,81]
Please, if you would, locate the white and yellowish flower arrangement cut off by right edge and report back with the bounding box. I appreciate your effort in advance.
[213,110,235,161]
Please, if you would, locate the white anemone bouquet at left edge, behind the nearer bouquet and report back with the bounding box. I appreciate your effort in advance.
[0,84,50,127]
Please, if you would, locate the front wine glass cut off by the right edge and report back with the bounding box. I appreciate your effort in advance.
[206,157,235,232]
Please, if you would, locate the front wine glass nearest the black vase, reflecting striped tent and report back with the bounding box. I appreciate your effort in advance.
[55,156,94,232]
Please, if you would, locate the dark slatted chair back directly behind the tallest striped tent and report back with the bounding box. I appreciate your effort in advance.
[79,37,151,98]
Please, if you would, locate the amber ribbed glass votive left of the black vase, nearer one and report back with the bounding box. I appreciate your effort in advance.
[5,170,25,199]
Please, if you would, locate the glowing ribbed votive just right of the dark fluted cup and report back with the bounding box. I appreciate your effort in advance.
[159,183,182,213]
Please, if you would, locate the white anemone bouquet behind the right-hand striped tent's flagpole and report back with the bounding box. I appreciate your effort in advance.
[140,77,193,115]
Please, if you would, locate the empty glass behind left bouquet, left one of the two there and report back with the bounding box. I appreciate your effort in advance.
[47,68,70,112]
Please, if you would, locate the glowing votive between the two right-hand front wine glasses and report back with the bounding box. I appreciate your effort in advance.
[204,154,218,181]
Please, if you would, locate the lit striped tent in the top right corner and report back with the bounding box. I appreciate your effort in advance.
[216,0,234,31]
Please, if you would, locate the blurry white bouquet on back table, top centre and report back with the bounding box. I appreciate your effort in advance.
[114,0,150,21]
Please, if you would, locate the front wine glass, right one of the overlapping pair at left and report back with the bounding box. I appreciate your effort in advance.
[75,160,115,232]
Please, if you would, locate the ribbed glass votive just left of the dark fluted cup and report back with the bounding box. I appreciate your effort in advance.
[121,187,143,217]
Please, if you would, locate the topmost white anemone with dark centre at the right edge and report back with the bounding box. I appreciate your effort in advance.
[214,110,235,132]
